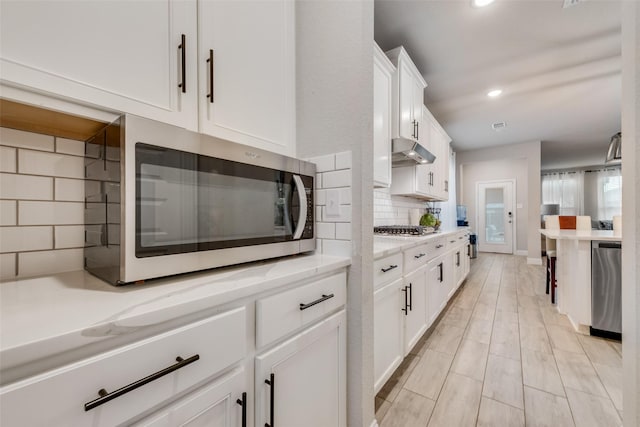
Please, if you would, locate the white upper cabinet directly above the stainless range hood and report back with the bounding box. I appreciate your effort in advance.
[386,46,427,141]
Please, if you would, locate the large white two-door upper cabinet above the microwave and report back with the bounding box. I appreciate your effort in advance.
[0,0,295,156]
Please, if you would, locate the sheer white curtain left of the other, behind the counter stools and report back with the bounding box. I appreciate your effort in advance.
[542,171,584,215]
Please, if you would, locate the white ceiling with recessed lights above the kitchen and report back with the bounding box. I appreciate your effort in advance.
[374,0,622,169]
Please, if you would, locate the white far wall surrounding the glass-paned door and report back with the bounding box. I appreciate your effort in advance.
[456,141,541,264]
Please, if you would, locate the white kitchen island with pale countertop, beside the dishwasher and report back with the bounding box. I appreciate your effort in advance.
[540,229,622,335]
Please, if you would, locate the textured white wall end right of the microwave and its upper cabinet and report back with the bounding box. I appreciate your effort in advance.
[296,0,375,427]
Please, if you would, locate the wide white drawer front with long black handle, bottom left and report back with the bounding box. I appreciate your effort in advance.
[0,308,246,427]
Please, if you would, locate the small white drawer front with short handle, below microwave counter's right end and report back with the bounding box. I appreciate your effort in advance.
[256,272,347,348]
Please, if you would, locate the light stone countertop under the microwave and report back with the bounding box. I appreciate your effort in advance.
[0,254,351,383]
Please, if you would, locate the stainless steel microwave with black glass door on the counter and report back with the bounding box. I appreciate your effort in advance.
[84,115,316,285]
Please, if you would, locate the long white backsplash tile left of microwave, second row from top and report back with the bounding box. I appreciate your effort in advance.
[18,150,84,179]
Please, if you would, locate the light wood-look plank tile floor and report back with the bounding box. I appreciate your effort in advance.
[376,253,622,427]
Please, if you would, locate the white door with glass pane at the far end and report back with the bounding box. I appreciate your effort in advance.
[476,181,515,254]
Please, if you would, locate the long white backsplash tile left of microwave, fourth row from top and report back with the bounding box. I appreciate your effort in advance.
[18,201,84,225]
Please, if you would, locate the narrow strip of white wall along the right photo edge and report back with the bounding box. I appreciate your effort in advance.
[622,1,640,427]
